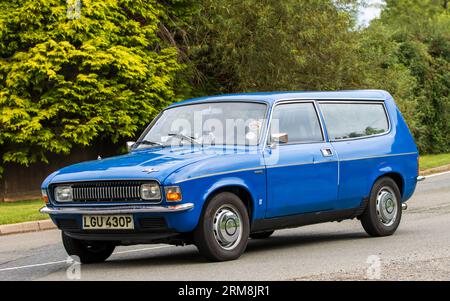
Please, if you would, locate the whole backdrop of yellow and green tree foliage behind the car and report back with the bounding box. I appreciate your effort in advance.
[0,0,450,176]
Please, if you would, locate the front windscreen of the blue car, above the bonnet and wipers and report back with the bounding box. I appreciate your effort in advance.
[136,102,266,148]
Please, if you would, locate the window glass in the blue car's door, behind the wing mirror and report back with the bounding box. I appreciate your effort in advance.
[270,102,323,143]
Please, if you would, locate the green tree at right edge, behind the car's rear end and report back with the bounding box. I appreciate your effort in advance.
[371,0,450,153]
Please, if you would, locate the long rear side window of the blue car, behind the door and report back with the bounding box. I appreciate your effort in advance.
[320,103,389,140]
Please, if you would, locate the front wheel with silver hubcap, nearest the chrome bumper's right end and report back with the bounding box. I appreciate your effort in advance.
[194,192,250,261]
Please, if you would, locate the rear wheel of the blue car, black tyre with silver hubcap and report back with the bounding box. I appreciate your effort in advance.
[361,177,402,236]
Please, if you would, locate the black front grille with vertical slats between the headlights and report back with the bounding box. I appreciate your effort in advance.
[51,181,159,202]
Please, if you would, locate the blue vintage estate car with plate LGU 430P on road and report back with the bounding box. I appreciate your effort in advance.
[41,90,419,263]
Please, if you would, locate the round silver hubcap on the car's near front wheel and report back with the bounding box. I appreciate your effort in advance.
[213,205,242,250]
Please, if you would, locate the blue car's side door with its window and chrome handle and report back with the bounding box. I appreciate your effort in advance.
[264,101,338,218]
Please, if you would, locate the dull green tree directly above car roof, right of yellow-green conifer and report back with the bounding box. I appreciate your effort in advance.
[182,0,361,93]
